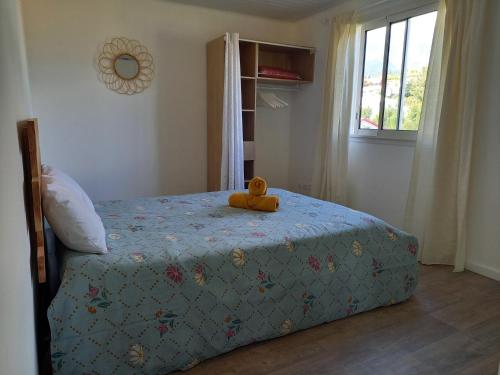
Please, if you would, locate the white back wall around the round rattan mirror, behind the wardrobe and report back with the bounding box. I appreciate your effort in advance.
[23,0,293,200]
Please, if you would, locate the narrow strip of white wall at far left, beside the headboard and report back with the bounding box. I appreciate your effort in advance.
[0,0,37,375]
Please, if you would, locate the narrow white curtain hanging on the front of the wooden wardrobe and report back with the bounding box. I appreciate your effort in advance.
[220,33,244,190]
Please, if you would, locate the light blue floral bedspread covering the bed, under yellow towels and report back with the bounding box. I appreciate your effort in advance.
[48,189,417,374]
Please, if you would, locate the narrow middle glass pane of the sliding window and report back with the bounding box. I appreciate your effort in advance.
[383,21,406,129]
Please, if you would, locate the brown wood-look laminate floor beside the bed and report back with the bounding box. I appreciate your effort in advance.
[177,266,500,375]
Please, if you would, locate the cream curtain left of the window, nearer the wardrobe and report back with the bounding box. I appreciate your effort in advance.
[313,15,356,204]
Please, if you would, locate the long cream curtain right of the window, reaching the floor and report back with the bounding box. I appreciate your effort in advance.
[405,0,489,271]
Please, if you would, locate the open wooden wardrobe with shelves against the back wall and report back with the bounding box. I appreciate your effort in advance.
[207,37,315,191]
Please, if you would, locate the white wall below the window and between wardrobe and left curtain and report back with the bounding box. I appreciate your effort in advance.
[290,4,414,226]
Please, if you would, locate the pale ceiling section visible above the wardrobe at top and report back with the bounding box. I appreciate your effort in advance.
[166,0,349,21]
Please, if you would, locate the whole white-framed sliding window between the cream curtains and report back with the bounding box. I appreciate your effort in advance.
[355,10,437,139]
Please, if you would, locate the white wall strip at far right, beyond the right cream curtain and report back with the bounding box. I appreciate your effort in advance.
[466,1,500,280]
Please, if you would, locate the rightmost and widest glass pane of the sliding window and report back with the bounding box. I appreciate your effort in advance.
[399,12,437,130]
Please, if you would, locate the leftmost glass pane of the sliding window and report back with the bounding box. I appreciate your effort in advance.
[359,26,386,129]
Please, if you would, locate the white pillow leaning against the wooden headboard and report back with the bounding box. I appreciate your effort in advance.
[41,172,108,254]
